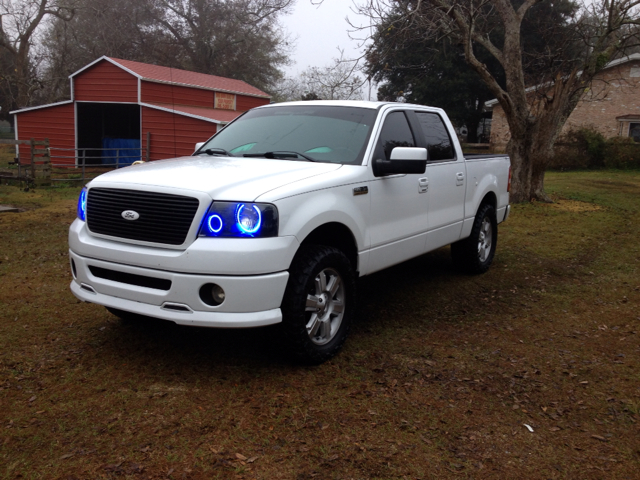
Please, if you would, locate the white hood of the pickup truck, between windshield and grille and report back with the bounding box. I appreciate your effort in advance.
[91,155,342,201]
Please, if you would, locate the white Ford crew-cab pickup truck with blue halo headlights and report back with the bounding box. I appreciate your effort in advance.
[69,101,511,363]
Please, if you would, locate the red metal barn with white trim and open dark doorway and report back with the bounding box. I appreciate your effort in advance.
[11,57,270,165]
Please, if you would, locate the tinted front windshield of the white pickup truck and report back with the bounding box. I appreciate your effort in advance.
[196,105,377,165]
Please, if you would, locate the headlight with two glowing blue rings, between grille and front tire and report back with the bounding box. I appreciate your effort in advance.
[199,202,278,238]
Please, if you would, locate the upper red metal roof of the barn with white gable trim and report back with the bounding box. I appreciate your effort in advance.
[69,56,271,98]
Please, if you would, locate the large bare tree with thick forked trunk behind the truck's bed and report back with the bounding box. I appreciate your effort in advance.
[359,0,640,202]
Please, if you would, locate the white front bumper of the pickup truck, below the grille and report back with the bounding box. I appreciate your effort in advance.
[69,250,289,328]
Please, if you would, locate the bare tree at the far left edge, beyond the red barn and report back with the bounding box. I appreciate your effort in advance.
[0,0,74,108]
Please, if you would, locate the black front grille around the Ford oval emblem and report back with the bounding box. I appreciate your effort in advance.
[87,188,199,245]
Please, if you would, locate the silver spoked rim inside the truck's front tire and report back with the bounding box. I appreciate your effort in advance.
[305,268,345,345]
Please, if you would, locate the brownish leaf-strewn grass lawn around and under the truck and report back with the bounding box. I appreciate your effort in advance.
[0,171,640,480]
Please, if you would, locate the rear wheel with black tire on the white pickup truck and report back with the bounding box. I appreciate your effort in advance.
[451,203,498,274]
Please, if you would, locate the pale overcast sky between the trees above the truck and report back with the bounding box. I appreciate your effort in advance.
[282,0,376,76]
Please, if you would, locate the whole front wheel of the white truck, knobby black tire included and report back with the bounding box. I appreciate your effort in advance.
[282,245,356,364]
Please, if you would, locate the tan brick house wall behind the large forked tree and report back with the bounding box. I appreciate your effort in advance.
[485,53,640,150]
